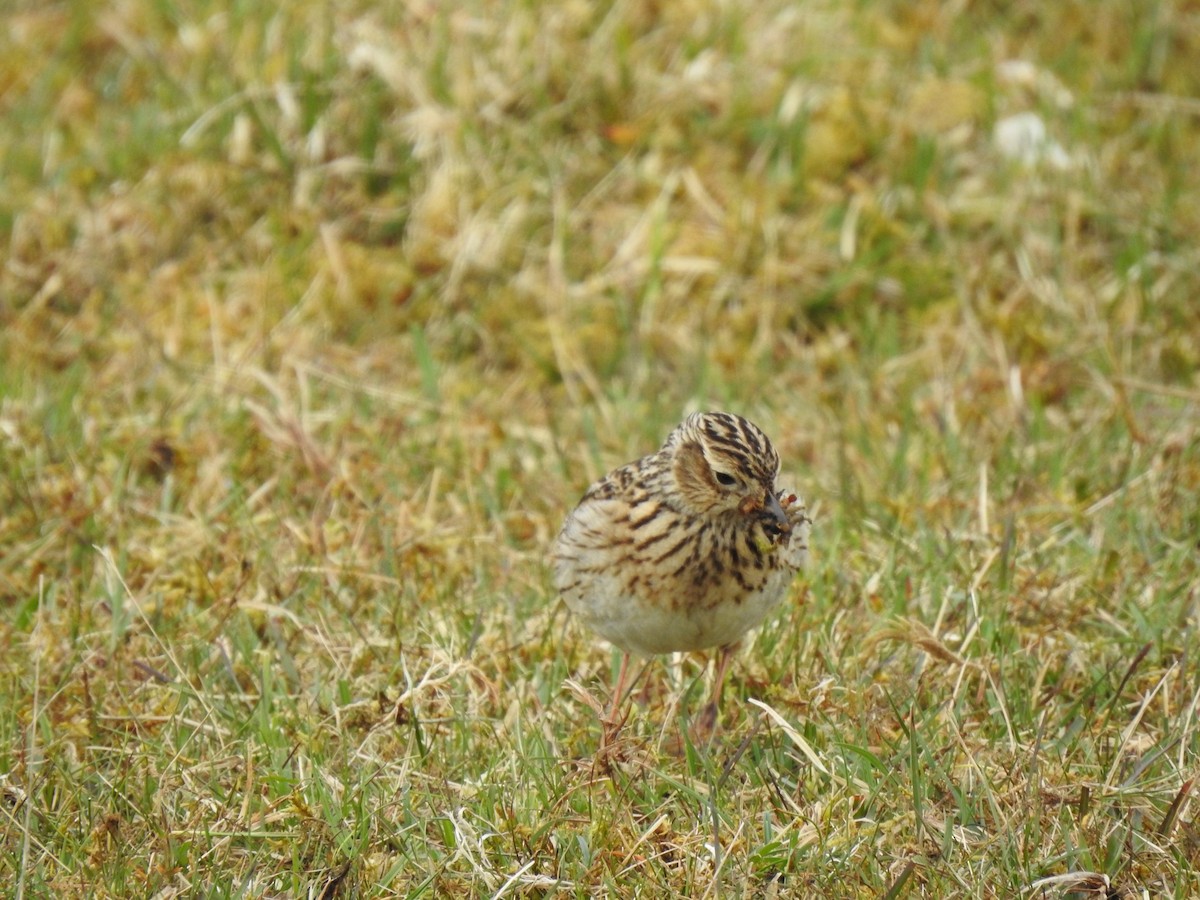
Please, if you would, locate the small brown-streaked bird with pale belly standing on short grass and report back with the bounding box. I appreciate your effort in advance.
[551,412,811,743]
